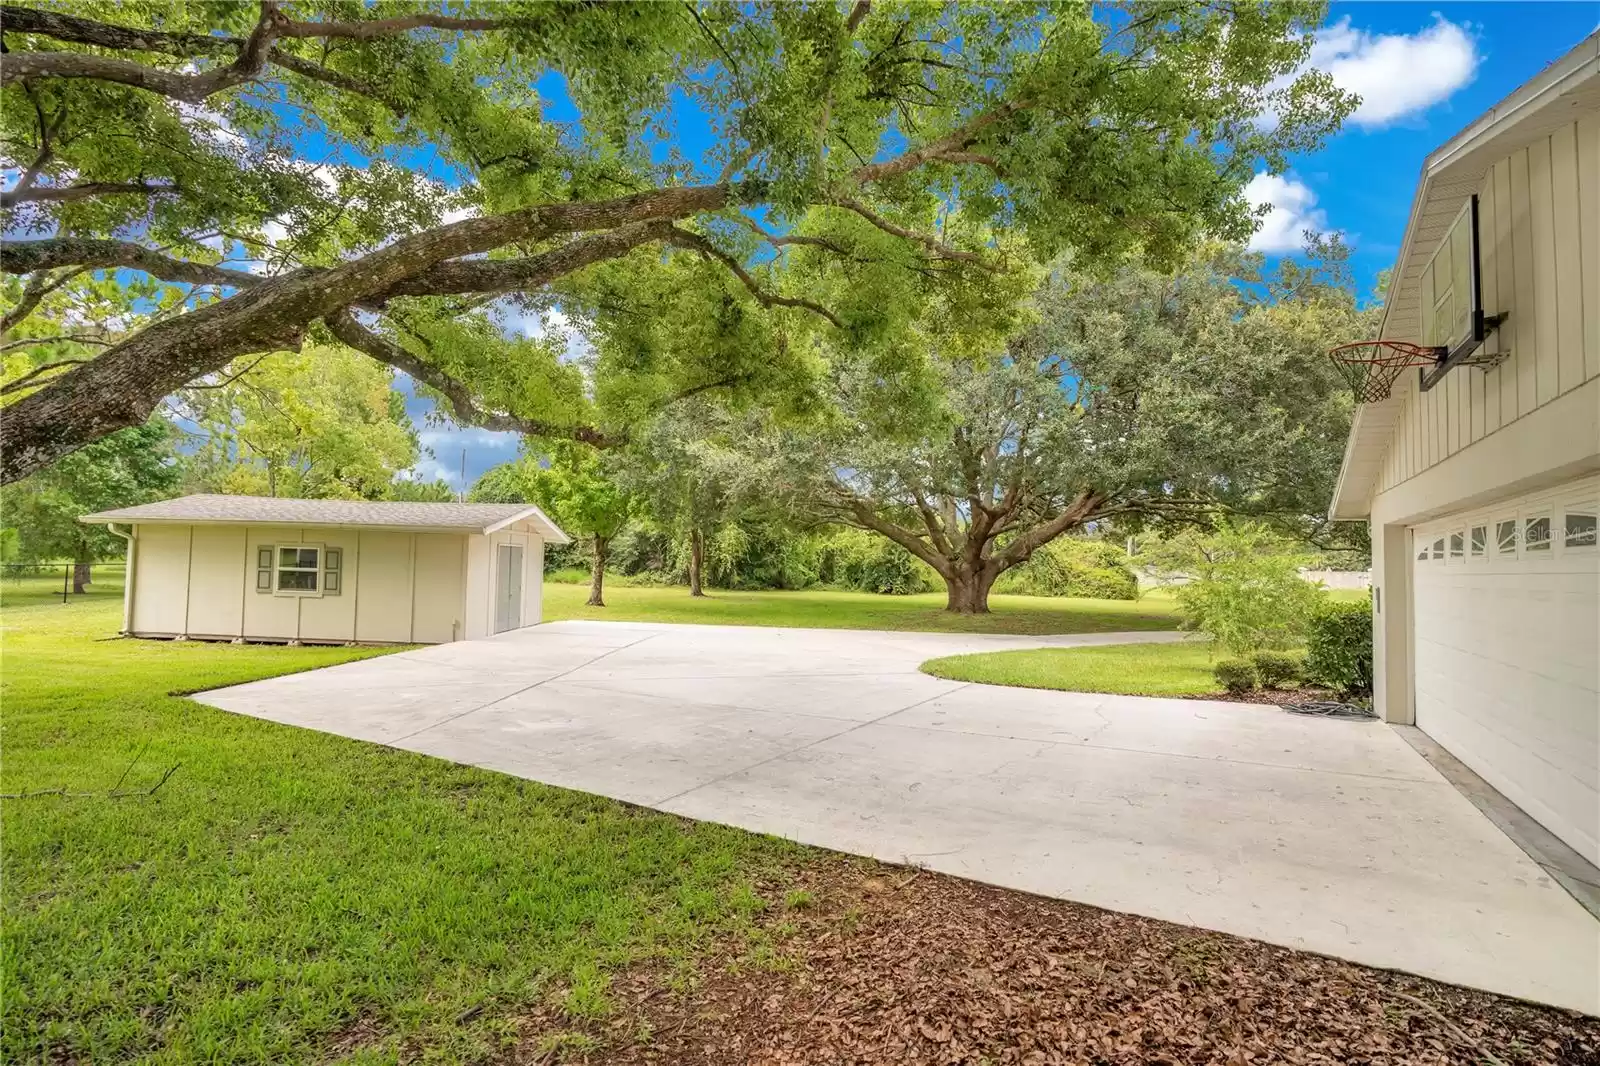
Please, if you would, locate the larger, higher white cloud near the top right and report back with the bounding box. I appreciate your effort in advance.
[1286,11,1482,126]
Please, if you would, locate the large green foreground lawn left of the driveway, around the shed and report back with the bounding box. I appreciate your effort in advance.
[0,581,808,1063]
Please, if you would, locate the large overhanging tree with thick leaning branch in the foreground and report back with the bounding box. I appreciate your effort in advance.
[0,0,1354,482]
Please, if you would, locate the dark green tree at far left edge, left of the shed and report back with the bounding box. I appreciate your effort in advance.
[0,418,181,592]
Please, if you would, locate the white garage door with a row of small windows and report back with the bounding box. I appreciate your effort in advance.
[1411,479,1600,864]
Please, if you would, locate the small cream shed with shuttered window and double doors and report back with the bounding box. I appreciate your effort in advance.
[82,495,566,643]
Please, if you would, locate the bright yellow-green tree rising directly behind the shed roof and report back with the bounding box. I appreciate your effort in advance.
[174,347,419,499]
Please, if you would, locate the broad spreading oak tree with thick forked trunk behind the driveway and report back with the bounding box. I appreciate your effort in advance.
[787,248,1360,613]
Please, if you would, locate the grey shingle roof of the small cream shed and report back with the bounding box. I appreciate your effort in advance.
[82,495,566,544]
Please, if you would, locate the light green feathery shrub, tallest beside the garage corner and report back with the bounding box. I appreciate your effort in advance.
[1150,523,1326,656]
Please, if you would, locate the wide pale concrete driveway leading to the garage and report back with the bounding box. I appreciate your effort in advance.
[197,621,1600,1012]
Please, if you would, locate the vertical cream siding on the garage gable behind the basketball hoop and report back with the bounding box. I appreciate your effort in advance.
[1378,114,1600,493]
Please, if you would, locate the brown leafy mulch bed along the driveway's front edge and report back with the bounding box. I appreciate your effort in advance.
[510,860,1600,1066]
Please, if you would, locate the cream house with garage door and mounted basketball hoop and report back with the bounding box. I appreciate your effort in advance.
[1330,34,1600,864]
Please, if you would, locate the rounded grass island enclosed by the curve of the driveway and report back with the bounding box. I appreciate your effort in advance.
[922,640,1222,696]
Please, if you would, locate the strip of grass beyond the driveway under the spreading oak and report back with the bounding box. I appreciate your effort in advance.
[544,583,1178,634]
